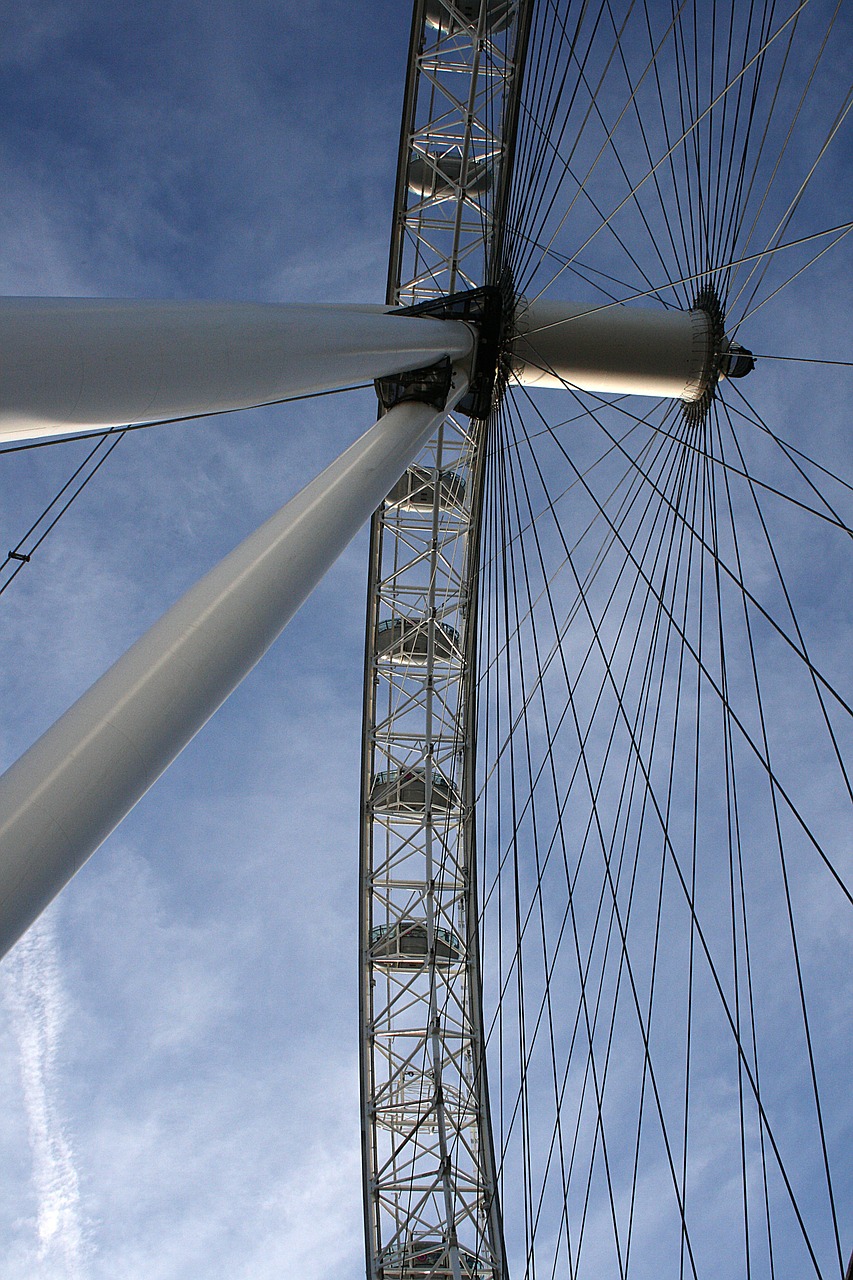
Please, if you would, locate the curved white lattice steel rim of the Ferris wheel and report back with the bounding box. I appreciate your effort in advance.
[361,0,530,1280]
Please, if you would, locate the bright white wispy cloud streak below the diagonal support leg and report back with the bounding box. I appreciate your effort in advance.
[3,911,90,1280]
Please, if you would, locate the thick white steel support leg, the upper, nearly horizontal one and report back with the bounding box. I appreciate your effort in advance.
[0,298,473,440]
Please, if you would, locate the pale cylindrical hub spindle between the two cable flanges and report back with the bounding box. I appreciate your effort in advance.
[512,301,715,402]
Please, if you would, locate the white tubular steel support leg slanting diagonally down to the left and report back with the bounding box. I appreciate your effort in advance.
[0,369,467,956]
